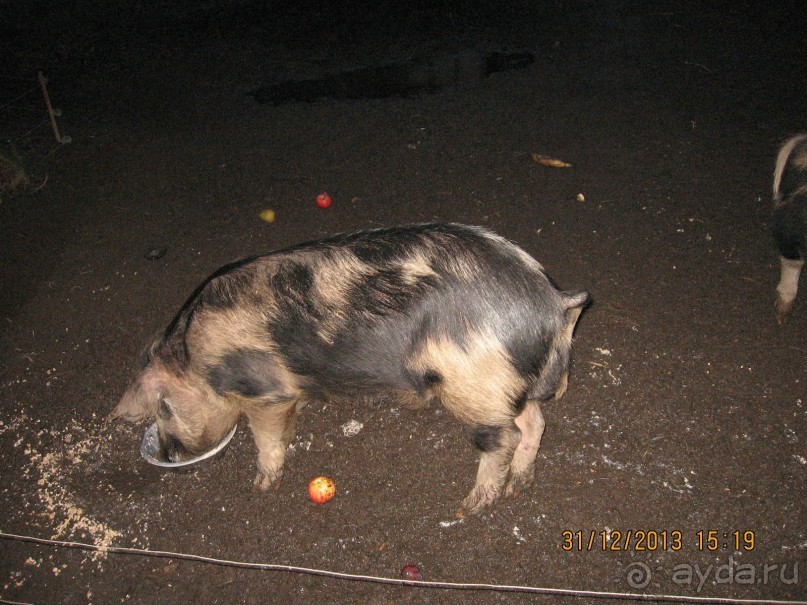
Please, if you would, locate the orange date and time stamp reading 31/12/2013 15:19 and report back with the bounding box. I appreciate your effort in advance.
[561,529,757,552]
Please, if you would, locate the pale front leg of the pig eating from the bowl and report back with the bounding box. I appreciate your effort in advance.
[246,401,298,492]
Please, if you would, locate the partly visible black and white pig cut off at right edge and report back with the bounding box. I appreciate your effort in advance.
[772,134,807,324]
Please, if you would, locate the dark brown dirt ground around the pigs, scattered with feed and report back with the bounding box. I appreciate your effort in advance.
[0,0,807,604]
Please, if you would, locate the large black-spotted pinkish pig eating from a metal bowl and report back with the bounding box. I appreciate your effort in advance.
[110,223,589,515]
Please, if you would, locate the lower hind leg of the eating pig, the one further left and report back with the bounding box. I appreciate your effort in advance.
[457,423,521,518]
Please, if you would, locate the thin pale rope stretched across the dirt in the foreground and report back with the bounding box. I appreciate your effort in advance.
[0,532,807,605]
